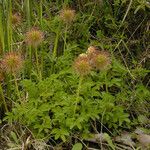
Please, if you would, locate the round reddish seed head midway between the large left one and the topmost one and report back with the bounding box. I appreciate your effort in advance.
[25,28,44,47]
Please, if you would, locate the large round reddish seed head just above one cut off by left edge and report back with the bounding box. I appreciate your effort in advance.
[1,52,23,73]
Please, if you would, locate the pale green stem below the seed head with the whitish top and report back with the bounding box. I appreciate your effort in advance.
[74,76,83,115]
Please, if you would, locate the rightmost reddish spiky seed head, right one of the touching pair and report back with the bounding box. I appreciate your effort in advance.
[91,51,111,70]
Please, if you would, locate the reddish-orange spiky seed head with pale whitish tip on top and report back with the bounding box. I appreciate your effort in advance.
[73,54,92,76]
